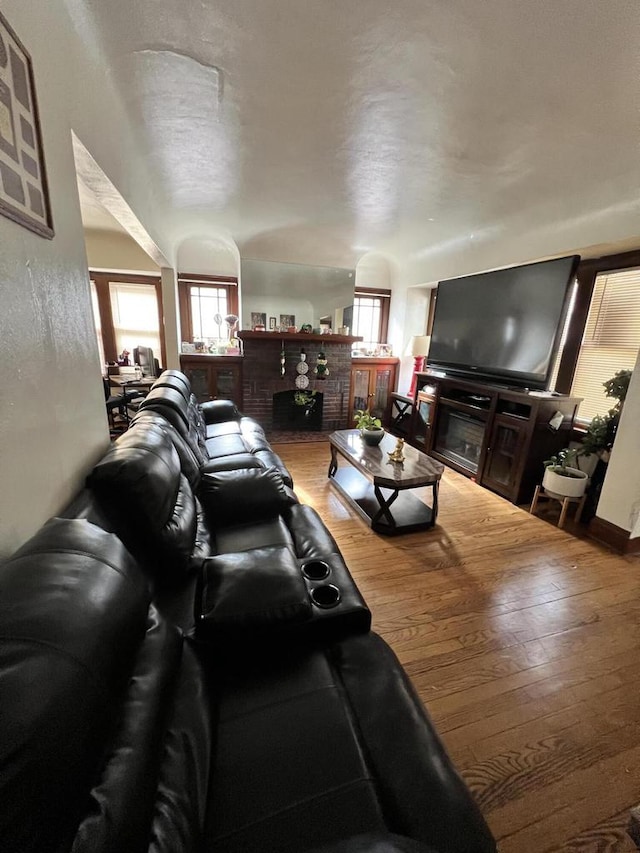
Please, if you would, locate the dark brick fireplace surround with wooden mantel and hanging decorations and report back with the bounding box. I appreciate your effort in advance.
[239,332,361,430]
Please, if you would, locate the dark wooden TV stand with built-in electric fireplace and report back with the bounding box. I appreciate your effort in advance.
[410,372,580,504]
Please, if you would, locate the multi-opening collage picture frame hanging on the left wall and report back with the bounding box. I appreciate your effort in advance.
[0,13,54,240]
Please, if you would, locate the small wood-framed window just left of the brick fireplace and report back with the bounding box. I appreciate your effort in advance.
[178,273,238,341]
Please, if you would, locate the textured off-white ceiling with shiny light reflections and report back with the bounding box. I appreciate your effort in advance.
[76,0,640,272]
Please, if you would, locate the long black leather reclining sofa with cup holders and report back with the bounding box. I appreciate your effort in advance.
[0,371,495,853]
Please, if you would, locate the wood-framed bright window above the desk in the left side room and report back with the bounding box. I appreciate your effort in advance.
[91,271,166,364]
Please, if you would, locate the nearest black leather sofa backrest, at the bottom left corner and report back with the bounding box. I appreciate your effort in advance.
[0,518,149,853]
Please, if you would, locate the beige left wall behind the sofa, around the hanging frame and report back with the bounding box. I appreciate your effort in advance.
[0,0,170,556]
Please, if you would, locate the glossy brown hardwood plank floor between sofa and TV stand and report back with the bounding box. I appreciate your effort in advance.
[274,443,640,853]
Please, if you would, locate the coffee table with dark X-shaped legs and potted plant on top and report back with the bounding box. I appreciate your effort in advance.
[328,429,444,535]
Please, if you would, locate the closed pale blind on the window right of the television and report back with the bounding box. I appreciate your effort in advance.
[571,268,640,422]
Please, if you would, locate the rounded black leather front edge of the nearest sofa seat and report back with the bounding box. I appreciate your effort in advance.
[330,633,497,853]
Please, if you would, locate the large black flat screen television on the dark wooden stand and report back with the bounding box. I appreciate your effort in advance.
[428,255,580,391]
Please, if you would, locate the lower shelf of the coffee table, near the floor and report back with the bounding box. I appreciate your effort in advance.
[331,468,437,536]
